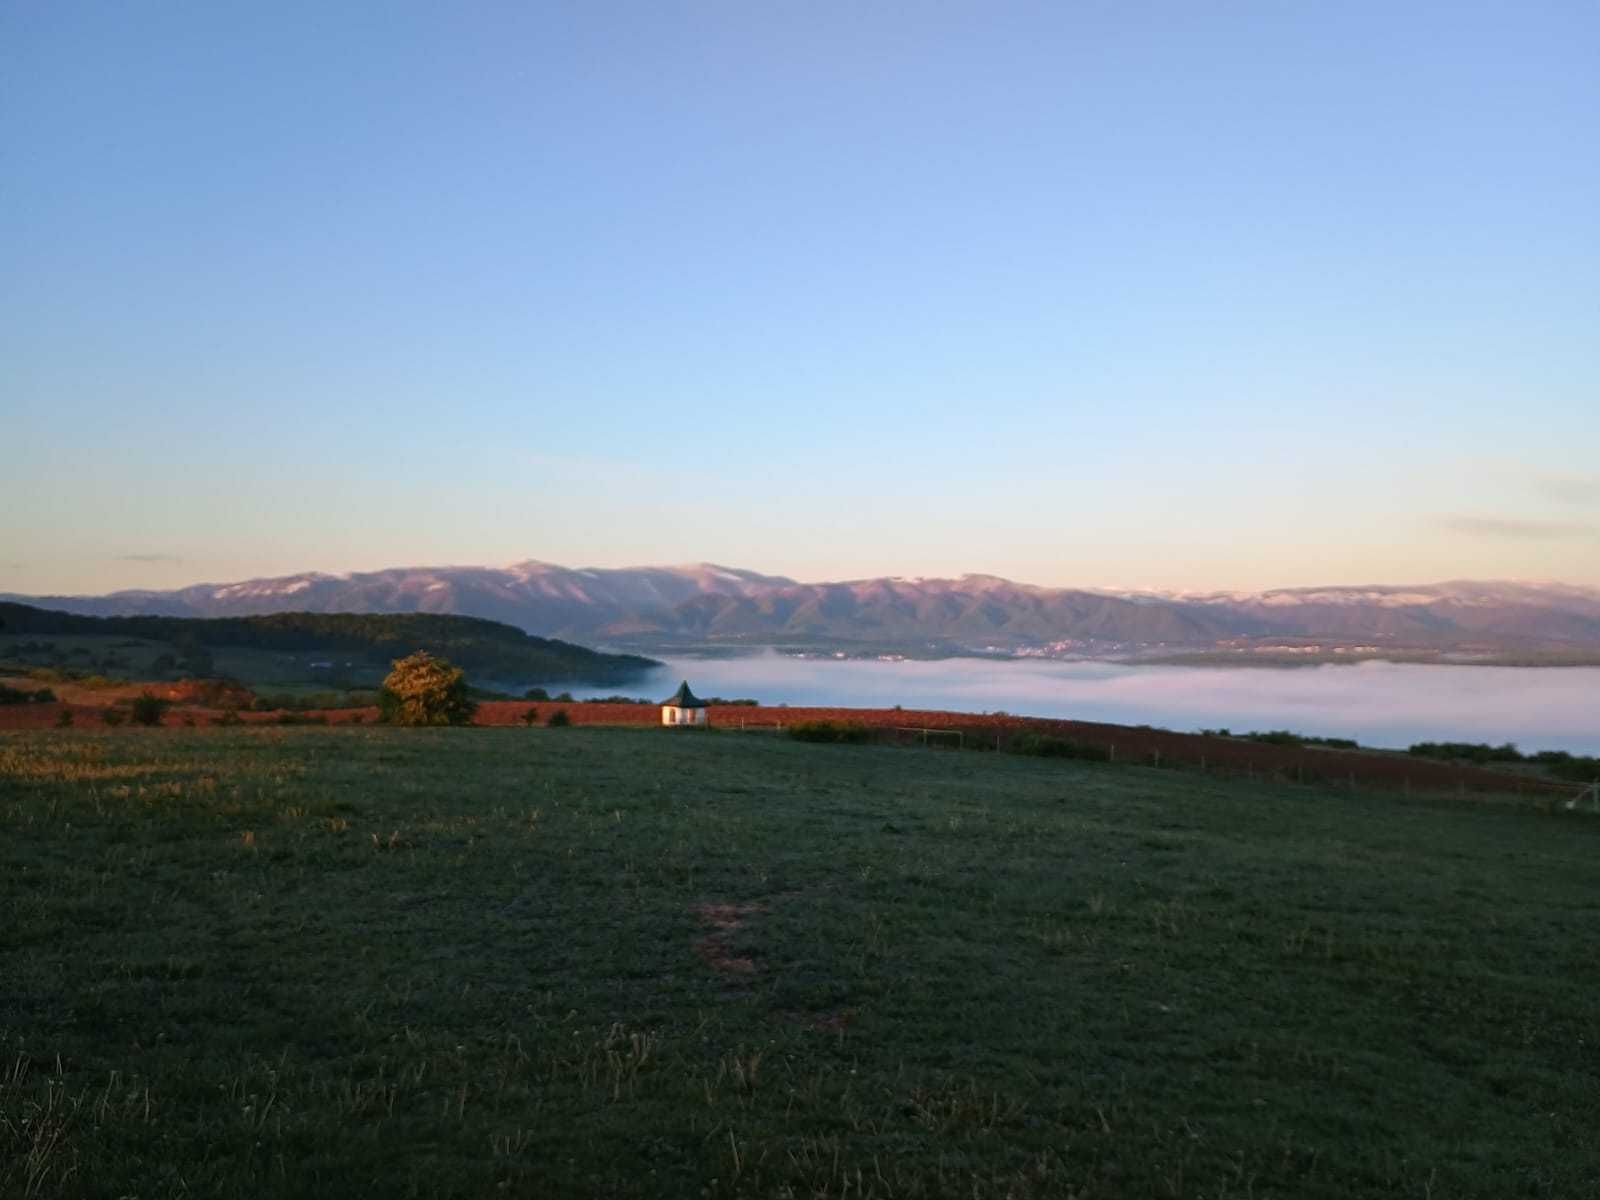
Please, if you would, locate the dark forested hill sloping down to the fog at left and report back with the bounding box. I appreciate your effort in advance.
[0,603,656,685]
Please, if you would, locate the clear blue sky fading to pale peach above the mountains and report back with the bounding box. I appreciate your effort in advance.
[0,0,1600,592]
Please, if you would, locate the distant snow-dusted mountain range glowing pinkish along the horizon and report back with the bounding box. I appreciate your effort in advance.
[12,562,1600,662]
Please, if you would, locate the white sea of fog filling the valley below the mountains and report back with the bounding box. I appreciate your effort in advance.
[573,653,1600,754]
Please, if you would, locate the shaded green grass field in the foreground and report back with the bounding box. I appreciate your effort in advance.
[0,728,1600,1198]
